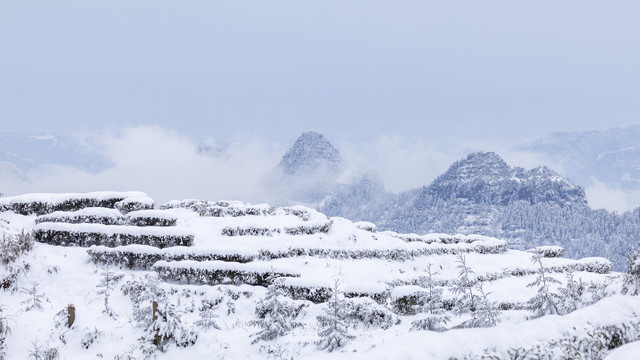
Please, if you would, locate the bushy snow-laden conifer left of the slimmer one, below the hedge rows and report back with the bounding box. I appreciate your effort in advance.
[251,284,306,344]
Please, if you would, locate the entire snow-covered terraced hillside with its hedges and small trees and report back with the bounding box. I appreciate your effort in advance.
[0,192,640,359]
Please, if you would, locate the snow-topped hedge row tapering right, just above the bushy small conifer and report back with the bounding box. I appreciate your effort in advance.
[153,260,300,286]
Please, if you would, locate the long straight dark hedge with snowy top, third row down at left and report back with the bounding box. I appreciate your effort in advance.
[33,223,194,248]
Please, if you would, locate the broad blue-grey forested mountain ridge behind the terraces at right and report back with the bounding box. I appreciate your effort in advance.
[280,131,640,269]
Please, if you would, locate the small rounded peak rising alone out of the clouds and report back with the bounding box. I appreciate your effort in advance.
[278,132,342,175]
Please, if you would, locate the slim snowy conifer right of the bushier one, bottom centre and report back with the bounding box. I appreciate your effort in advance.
[317,278,353,352]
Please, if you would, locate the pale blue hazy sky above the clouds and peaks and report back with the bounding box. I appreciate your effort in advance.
[0,0,640,143]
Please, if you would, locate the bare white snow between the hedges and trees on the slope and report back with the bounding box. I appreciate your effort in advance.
[0,194,640,359]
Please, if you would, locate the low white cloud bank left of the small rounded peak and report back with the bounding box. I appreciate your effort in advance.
[2,126,282,203]
